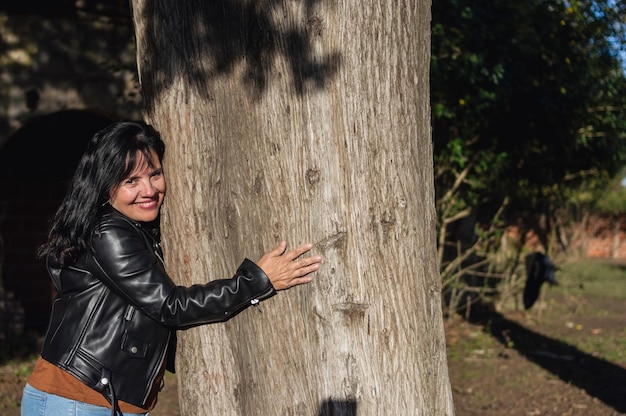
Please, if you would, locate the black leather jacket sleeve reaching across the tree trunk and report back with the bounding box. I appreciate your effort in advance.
[92,219,276,329]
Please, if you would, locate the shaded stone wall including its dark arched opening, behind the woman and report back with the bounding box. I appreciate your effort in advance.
[0,0,141,346]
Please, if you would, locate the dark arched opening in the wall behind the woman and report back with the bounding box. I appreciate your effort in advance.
[0,110,112,338]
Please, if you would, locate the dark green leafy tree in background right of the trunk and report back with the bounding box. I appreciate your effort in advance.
[431,0,626,312]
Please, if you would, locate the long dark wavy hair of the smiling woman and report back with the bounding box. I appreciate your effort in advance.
[37,121,165,265]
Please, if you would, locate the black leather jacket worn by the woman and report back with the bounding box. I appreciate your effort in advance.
[42,208,276,407]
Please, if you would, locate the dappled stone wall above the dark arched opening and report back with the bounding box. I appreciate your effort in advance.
[0,4,141,147]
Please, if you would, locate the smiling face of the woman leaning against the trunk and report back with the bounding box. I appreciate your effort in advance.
[109,150,165,222]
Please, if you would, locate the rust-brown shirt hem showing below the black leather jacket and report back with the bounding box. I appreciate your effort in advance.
[28,357,165,414]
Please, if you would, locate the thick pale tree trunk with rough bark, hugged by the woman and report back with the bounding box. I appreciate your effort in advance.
[133,0,454,416]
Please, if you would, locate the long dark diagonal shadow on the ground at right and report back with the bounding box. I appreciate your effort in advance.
[480,312,626,413]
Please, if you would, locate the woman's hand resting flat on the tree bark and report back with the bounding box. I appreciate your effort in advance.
[257,241,322,290]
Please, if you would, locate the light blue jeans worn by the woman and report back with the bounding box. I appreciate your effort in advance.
[22,384,148,416]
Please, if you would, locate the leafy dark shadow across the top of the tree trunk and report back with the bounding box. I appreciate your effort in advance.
[134,0,340,108]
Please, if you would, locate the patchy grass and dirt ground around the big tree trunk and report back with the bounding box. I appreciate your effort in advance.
[0,264,626,416]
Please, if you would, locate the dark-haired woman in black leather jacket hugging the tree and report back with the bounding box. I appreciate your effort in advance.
[22,121,322,416]
